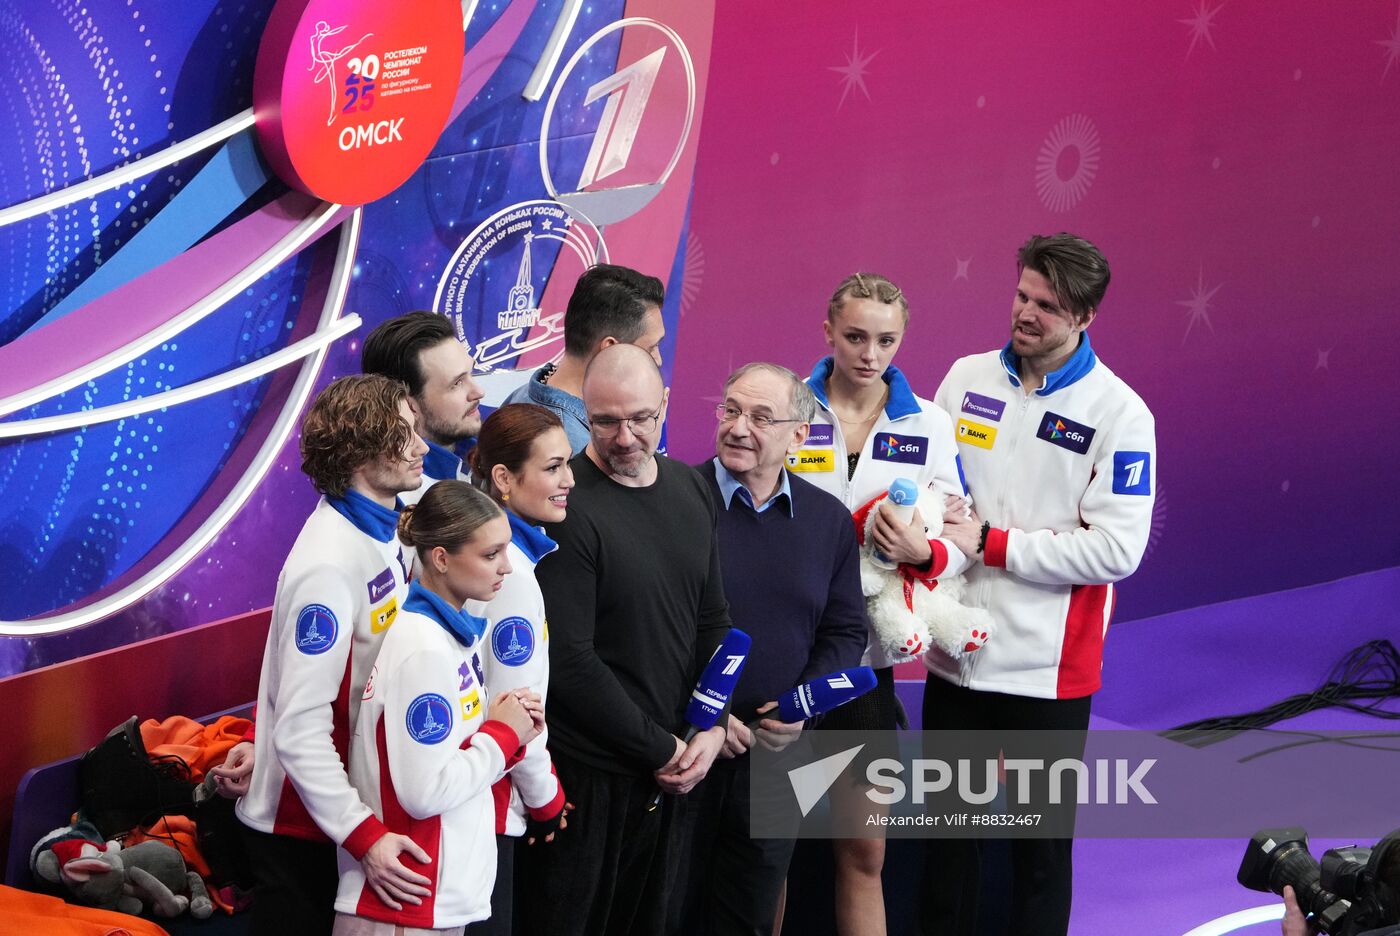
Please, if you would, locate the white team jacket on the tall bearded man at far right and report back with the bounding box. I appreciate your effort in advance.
[924,334,1156,698]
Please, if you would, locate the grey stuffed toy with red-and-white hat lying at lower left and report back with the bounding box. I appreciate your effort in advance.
[29,827,214,919]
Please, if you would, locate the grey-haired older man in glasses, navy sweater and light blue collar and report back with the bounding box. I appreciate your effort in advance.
[672,362,867,936]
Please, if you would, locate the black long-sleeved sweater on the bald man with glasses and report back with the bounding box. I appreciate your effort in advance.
[535,452,729,774]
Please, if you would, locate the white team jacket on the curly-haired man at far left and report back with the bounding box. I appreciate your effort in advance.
[237,491,406,858]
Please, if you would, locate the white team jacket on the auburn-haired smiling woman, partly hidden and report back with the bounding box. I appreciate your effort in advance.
[466,512,564,835]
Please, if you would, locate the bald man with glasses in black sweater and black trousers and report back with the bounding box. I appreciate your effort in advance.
[519,344,729,936]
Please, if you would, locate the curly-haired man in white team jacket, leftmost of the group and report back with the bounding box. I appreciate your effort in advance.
[238,375,428,936]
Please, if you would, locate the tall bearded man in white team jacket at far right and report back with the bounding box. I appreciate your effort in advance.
[923,234,1156,936]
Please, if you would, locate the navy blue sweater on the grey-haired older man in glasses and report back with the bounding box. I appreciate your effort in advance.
[696,462,868,721]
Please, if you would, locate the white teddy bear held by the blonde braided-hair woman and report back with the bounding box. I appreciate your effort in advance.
[854,488,995,662]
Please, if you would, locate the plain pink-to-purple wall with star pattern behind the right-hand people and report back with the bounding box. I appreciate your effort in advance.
[672,0,1400,620]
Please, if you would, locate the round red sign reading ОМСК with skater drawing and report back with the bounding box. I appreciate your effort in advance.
[253,0,463,204]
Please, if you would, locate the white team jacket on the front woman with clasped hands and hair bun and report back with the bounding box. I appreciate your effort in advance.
[336,582,519,929]
